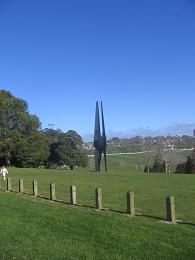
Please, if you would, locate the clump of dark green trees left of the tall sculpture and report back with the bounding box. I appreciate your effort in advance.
[0,90,87,169]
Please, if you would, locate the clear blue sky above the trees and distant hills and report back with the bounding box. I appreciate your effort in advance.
[0,0,195,138]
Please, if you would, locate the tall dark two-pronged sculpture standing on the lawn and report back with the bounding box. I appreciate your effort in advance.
[94,102,107,172]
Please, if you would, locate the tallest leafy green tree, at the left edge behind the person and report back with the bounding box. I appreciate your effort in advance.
[0,90,49,167]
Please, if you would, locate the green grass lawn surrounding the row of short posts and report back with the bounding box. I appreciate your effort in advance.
[0,155,195,259]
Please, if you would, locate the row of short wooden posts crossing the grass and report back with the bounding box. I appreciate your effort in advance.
[4,177,176,224]
